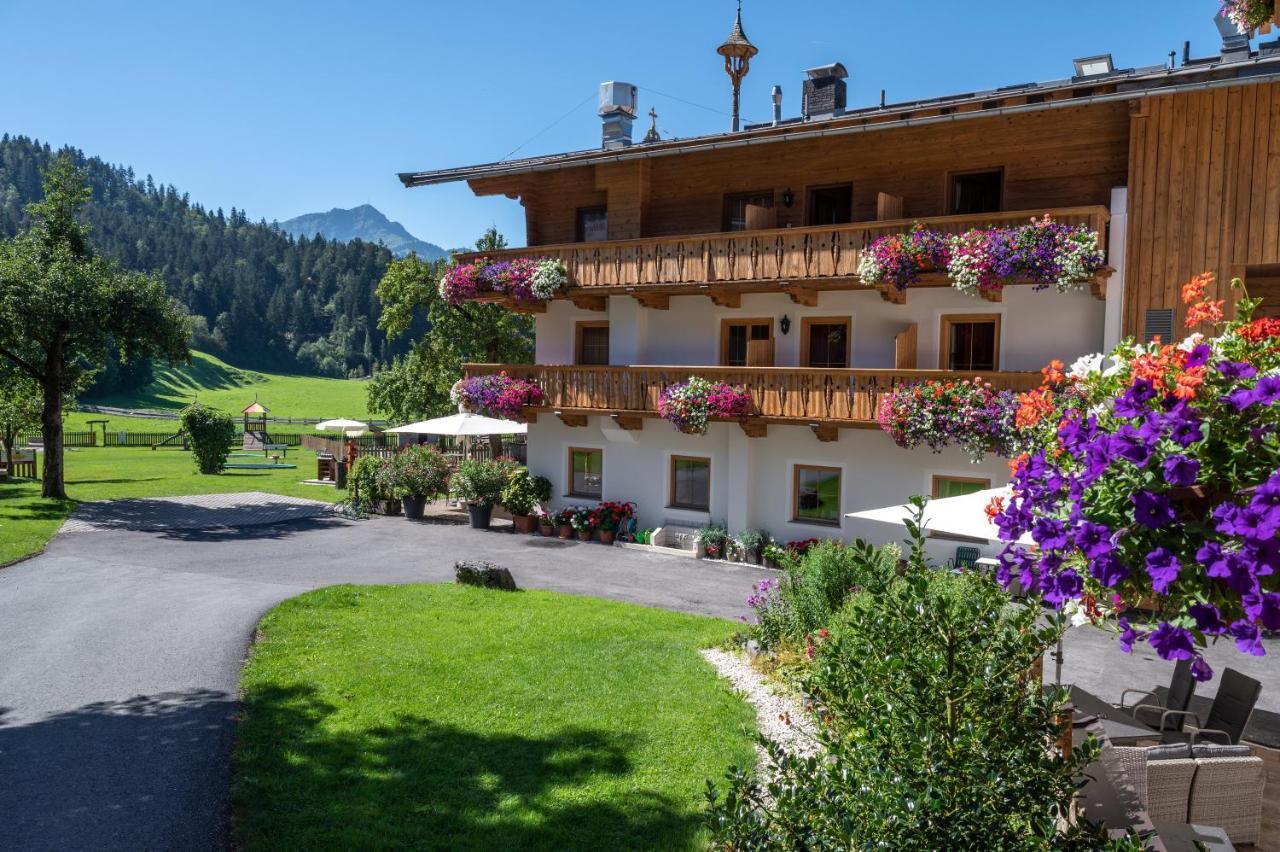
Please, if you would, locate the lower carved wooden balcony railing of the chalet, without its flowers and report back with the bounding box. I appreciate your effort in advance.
[463,363,1041,440]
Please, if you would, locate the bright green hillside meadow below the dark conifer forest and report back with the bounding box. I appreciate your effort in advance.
[67,352,369,431]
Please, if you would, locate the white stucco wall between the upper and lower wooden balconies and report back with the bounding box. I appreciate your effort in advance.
[538,285,1105,370]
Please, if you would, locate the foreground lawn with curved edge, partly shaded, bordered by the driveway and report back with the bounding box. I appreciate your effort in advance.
[232,586,755,851]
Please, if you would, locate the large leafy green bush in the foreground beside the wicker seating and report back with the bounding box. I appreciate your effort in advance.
[708,498,1142,851]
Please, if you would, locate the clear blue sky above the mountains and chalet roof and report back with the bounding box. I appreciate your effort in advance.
[0,0,1219,247]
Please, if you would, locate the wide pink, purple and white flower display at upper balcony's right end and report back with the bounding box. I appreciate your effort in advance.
[858,214,1103,296]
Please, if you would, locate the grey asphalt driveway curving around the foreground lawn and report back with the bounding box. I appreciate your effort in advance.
[0,494,763,852]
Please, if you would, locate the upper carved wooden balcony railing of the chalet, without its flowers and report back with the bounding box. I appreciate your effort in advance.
[456,206,1111,310]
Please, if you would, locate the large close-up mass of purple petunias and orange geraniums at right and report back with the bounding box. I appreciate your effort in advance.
[993,275,1280,679]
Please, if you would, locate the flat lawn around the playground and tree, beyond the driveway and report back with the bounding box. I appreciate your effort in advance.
[0,446,347,565]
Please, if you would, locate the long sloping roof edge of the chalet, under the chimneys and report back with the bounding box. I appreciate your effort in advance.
[398,40,1280,188]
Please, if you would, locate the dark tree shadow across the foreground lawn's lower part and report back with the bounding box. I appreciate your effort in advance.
[232,688,700,849]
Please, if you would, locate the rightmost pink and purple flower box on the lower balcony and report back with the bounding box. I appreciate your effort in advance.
[877,379,1019,462]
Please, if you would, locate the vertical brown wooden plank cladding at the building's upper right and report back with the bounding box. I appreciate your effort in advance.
[1124,82,1280,335]
